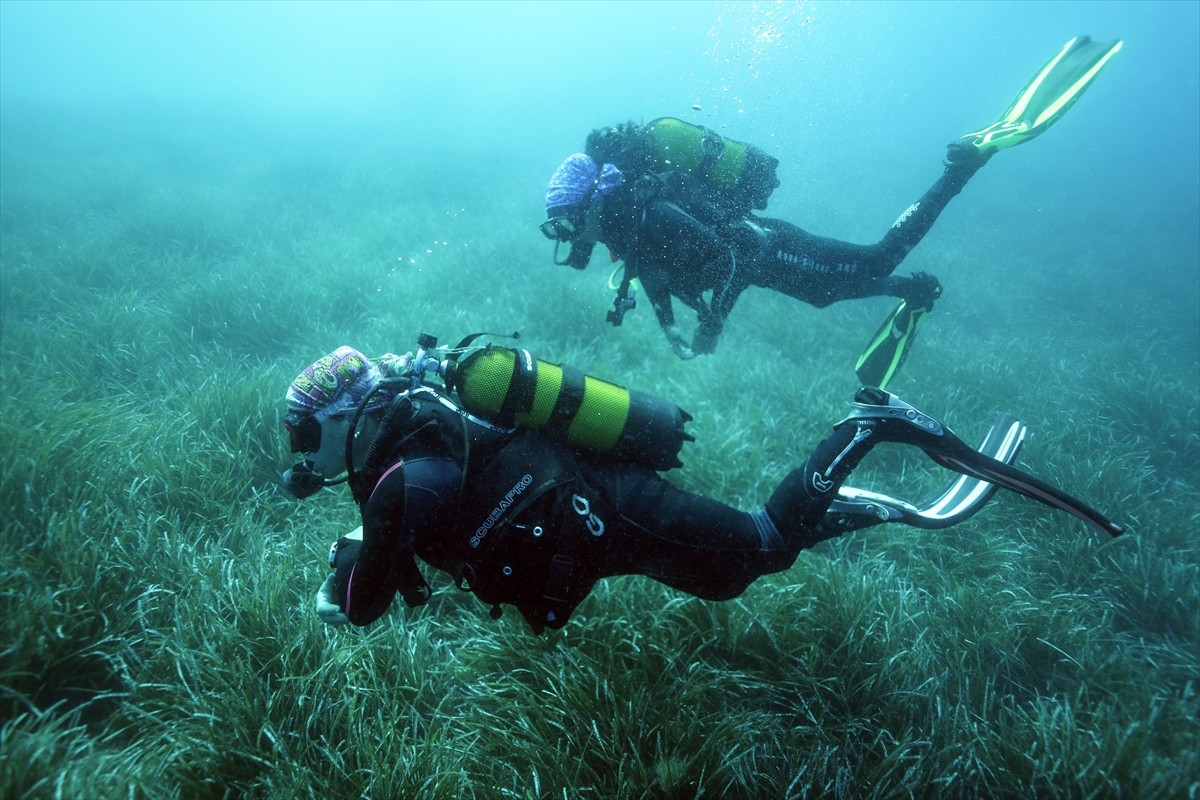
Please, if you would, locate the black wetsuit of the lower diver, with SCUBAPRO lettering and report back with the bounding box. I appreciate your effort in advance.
[332,391,892,631]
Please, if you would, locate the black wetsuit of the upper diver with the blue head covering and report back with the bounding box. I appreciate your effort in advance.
[585,161,983,336]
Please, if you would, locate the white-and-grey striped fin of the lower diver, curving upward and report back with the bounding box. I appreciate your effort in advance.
[820,414,1026,536]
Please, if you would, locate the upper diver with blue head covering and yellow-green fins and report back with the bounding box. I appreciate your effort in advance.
[541,36,1121,387]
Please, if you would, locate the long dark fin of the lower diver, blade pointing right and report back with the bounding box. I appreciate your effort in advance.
[834,386,1124,536]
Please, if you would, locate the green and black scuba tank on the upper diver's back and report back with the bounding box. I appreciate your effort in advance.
[644,116,779,209]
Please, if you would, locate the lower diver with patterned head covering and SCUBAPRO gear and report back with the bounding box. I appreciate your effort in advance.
[282,335,1122,633]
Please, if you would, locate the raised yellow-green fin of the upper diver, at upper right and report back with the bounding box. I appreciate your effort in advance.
[950,36,1122,154]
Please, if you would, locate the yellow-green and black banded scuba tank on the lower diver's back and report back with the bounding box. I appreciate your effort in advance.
[448,347,695,470]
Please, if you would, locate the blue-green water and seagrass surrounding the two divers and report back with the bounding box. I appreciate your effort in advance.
[0,0,1200,798]
